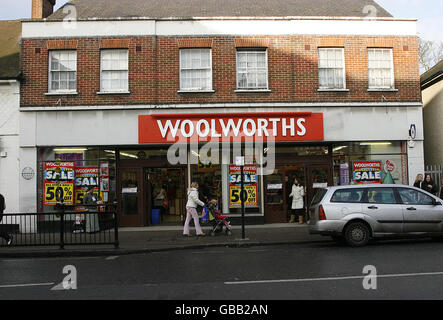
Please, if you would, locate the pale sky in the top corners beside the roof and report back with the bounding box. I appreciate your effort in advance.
[0,0,443,42]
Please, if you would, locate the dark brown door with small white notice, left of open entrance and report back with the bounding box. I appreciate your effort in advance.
[118,168,143,227]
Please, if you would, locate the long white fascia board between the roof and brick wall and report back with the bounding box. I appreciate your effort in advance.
[22,18,417,39]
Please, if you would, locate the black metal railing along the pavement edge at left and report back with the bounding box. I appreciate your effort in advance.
[0,205,119,249]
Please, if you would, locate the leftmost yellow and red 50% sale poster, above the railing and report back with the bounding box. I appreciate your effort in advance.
[44,161,75,206]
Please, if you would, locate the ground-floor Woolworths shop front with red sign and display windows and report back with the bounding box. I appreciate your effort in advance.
[24,104,422,227]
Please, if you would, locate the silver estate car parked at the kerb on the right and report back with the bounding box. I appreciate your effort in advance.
[308,184,443,247]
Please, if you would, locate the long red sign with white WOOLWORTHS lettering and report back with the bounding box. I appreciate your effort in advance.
[138,112,324,143]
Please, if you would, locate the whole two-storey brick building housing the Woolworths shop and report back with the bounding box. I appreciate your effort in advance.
[20,0,423,226]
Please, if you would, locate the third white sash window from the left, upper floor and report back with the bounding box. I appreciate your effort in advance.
[180,49,212,91]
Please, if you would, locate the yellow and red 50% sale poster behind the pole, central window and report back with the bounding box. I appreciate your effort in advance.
[229,165,258,208]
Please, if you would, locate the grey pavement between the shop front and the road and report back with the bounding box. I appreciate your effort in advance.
[0,223,331,258]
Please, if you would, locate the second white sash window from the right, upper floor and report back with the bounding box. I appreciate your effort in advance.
[318,48,346,89]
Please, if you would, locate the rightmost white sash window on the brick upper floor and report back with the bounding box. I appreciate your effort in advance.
[368,49,394,89]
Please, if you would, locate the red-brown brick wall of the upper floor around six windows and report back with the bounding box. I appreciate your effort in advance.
[21,36,421,106]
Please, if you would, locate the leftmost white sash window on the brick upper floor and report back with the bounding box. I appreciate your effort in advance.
[49,50,77,93]
